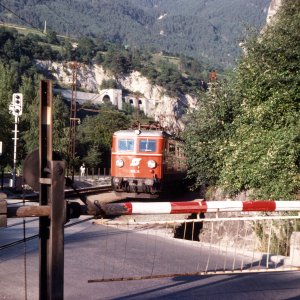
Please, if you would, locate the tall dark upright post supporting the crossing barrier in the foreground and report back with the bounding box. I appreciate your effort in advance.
[39,80,65,300]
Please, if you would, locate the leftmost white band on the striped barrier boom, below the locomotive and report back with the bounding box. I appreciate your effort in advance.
[132,202,171,214]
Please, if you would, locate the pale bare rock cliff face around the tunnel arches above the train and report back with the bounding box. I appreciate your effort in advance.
[37,61,196,132]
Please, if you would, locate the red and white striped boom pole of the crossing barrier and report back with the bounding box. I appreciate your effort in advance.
[102,200,300,215]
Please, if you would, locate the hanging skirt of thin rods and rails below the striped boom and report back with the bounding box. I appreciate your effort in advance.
[89,215,300,283]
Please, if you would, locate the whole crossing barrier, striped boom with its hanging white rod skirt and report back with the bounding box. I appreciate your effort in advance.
[89,200,300,283]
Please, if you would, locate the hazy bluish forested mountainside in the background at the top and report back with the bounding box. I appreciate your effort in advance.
[0,0,270,67]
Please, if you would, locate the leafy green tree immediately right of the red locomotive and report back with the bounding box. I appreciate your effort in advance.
[184,81,239,190]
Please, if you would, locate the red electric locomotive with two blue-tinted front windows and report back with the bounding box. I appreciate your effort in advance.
[111,130,186,198]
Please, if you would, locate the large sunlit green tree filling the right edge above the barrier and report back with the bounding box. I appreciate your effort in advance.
[221,0,300,199]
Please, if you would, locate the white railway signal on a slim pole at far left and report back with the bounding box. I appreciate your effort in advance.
[9,93,23,188]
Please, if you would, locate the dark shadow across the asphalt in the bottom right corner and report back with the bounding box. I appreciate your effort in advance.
[112,272,300,300]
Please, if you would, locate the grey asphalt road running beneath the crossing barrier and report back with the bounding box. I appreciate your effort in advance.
[0,217,300,300]
